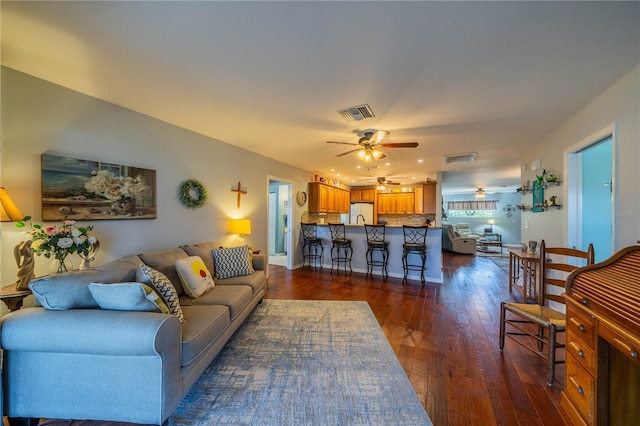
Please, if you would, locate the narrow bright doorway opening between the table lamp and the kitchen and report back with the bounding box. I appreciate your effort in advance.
[267,177,292,269]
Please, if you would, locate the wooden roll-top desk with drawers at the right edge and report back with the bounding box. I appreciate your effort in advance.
[560,246,640,426]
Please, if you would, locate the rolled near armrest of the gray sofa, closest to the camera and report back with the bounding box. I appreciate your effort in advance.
[1,308,181,356]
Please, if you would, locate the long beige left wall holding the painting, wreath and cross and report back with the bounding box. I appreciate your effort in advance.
[0,68,312,288]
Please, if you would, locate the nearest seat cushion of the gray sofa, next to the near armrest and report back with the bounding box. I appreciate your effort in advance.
[181,305,231,366]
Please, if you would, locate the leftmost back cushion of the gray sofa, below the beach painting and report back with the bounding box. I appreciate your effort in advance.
[29,255,140,310]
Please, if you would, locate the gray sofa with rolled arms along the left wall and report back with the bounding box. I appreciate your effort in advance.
[1,243,266,424]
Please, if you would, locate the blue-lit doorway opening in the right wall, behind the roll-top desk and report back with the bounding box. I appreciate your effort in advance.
[565,125,617,262]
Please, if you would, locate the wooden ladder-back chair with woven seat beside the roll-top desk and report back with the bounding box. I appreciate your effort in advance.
[500,240,594,386]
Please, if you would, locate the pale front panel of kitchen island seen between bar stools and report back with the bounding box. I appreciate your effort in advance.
[318,224,442,284]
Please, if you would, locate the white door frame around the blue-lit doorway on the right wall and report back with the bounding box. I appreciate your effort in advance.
[563,123,618,253]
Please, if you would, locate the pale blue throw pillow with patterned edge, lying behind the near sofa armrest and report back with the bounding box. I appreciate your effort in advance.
[89,282,169,314]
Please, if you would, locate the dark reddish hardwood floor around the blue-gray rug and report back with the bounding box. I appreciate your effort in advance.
[266,253,565,426]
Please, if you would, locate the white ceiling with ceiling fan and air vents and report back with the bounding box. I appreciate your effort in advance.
[1,1,640,193]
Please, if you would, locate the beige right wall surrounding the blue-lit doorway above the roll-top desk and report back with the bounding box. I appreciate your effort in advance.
[522,65,640,250]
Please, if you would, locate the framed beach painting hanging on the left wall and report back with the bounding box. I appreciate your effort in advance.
[42,154,156,221]
